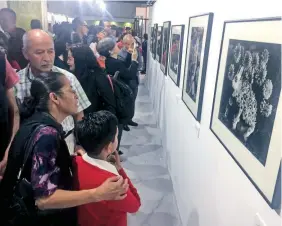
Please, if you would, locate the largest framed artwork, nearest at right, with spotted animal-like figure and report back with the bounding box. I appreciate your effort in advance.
[211,17,282,209]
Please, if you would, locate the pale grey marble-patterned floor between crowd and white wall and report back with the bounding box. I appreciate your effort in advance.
[121,85,181,226]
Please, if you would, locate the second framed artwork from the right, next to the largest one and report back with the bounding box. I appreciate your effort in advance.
[182,13,213,122]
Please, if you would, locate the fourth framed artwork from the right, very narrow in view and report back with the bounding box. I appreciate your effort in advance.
[160,21,171,75]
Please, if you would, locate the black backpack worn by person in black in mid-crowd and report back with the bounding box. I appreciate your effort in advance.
[111,71,134,121]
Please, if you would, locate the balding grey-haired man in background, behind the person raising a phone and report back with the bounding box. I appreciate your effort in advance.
[118,34,142,131]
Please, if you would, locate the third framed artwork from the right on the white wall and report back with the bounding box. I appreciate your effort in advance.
[168,25,185,86]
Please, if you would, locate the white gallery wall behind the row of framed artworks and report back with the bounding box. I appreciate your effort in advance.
[147,0,282,226]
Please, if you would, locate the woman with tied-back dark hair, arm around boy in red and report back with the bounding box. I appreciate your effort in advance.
[0,72,128,226]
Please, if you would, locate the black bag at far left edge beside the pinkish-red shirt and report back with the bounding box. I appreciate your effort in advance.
[0,53,11,161]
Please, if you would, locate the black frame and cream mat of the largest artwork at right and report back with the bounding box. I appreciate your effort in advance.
[210,17,282,209]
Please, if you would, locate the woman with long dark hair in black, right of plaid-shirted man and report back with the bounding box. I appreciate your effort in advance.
[68,46,123,154]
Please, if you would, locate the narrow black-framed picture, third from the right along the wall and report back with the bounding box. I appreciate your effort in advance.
[168,24,185,86]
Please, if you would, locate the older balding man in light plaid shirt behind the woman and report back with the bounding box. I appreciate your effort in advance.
[15,29,90,154]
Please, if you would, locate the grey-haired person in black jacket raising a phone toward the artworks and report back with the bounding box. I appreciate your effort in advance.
[97,37,139,131]
